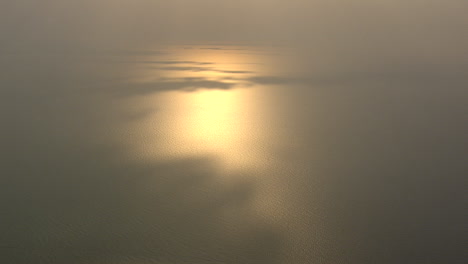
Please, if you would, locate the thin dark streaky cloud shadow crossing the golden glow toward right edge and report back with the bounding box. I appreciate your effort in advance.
[104,56,466,99]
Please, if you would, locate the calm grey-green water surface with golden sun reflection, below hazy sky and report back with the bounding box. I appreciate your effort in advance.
[0,45,468,264]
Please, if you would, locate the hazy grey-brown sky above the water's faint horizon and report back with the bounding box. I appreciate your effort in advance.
[0,0,468,52]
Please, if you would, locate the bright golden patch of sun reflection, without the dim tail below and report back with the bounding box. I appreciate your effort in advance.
[120,46,284,169]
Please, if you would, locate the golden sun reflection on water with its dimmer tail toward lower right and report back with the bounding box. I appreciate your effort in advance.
[118,47,326,263]
